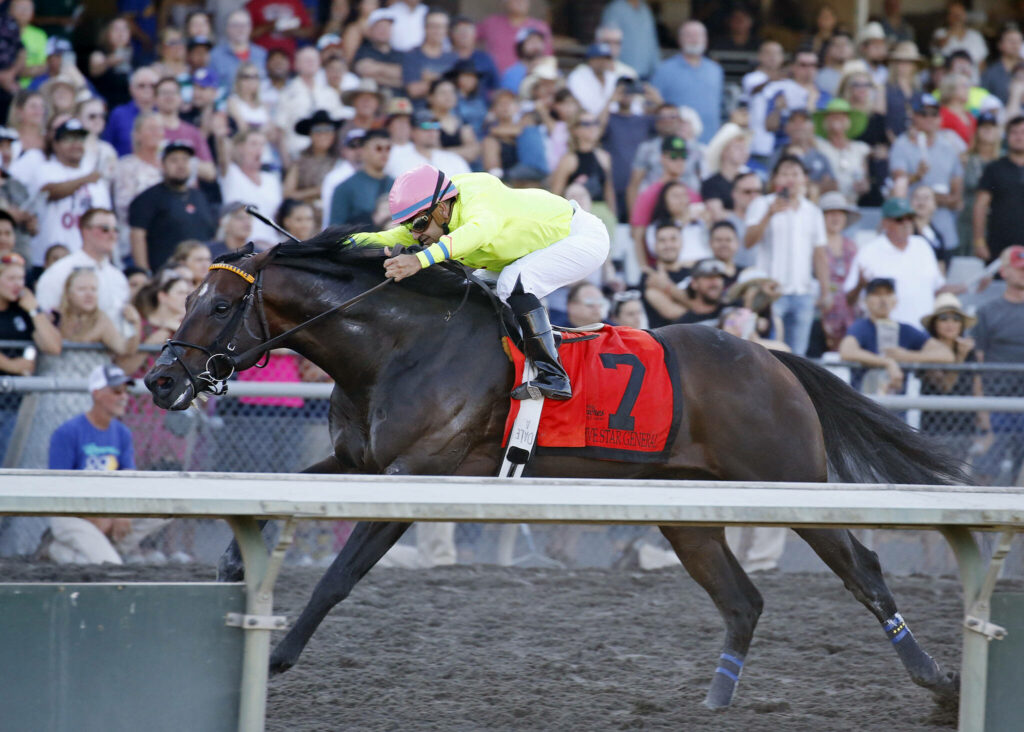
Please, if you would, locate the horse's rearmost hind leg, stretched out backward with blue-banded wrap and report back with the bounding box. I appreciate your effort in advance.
[796,528,959,701]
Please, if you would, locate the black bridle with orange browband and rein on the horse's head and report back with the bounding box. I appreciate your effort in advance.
[164,254,393,396]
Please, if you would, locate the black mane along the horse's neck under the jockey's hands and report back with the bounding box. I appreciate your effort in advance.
[216,226,482,299]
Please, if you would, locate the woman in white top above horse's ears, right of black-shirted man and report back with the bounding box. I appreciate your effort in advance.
[220,129,283,249]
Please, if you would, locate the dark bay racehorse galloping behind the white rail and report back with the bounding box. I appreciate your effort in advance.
[145,229,963,707]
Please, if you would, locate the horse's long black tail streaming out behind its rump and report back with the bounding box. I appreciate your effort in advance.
[772,351,971,484]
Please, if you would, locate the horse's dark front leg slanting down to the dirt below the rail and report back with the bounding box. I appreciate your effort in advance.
[270,521,413,674]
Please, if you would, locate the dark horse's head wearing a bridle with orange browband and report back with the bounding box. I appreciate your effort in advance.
[144,250,269,410]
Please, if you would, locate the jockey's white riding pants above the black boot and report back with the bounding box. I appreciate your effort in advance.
[498,201,610,302]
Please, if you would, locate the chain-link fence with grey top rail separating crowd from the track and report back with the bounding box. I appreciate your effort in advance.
[0,343,1024,575]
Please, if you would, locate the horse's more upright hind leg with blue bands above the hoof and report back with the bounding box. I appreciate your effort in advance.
[659,526,764,709]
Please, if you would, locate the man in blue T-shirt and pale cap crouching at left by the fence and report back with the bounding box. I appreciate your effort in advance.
[40,363,160,564]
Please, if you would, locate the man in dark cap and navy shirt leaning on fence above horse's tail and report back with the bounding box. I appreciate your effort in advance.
[839,277,953,393]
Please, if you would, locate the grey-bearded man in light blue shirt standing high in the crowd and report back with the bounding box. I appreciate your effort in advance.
[651,20,725,142]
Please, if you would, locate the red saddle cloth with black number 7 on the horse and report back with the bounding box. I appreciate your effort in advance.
[502,326,682,463]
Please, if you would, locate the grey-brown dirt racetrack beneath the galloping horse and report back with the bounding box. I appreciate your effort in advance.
[6,561,999,732]
